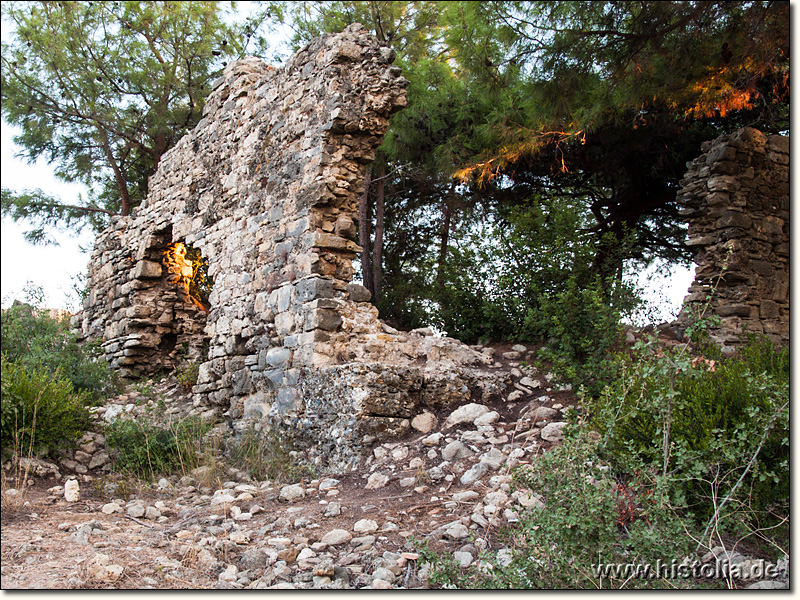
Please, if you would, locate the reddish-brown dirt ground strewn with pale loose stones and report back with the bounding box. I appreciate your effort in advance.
[2,340,788,590]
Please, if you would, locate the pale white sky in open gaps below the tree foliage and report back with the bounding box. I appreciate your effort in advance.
[0,3,693,321]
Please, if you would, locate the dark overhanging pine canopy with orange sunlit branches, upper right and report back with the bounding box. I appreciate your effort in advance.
[448,2,789,270]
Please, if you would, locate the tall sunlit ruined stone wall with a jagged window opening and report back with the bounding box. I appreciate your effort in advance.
[74,25,508,468]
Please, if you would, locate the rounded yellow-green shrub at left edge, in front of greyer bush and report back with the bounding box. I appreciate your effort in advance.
[0,352,91,456]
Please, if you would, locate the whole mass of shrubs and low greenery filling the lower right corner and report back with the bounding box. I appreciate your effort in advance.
[421,337,789,589]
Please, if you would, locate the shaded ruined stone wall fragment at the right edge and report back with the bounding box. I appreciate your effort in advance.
[678,128,789,350]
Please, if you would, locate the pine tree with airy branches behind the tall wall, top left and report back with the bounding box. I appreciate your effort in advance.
[2,2,241,240]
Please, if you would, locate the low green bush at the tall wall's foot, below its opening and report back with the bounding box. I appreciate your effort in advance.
[106,417,210,478]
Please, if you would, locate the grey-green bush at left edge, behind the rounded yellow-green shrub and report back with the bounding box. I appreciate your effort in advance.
[0,289,115,402]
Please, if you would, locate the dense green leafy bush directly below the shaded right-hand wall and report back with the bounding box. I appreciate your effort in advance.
[592,338,789,519]
